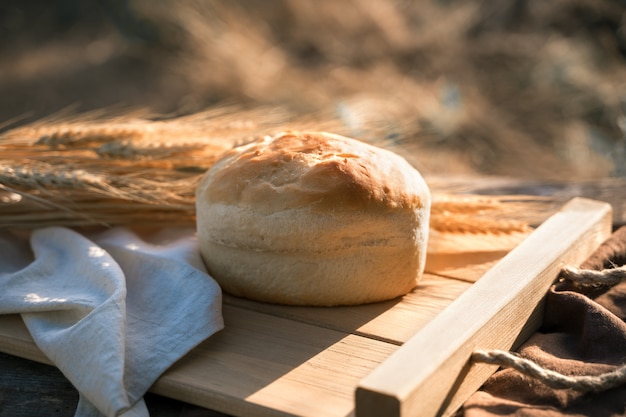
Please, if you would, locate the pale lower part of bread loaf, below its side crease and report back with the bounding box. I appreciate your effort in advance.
[203,242,423,306]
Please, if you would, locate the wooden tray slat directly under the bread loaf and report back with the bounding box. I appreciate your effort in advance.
[224,274,471,344]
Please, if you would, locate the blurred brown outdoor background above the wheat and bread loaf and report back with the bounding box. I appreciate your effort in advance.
[0,0,626,180]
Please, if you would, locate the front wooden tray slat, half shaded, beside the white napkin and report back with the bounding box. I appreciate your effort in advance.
[151,306,397,417]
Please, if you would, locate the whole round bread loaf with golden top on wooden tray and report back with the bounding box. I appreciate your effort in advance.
[196,132,431,306]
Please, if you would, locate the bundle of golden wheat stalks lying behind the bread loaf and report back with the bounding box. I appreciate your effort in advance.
[0,108,527,233]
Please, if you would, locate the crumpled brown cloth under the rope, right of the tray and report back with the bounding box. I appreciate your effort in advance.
[459,227,626,417]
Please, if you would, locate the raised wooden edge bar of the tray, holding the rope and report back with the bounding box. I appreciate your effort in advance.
[356,199,612,417]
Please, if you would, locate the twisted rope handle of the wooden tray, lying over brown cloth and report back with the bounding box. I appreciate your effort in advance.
[472,265,626,393]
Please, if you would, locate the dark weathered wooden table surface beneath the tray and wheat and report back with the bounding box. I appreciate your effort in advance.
[0,178,626,417]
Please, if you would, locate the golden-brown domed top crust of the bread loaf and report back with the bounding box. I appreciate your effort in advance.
[206,132,422,211]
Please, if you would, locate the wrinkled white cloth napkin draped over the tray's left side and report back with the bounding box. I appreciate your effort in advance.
[0,227,223,417]
